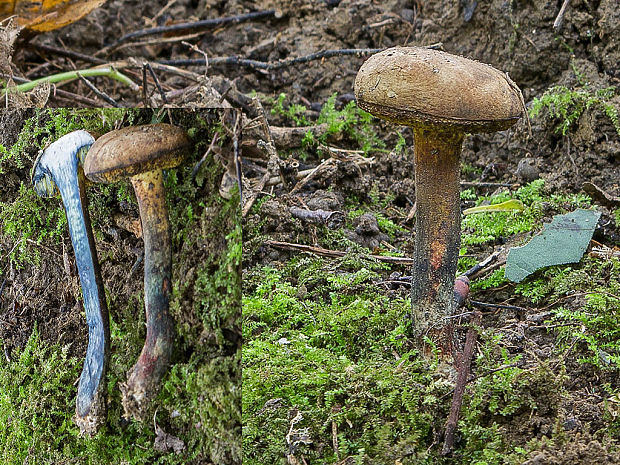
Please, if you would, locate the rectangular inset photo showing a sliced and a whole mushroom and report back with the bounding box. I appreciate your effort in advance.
[0,108,242,465]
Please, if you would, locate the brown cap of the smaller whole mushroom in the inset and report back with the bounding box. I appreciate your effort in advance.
[84,123,191,183]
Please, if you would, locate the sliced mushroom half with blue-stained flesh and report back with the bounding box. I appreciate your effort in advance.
[32,131,110,435]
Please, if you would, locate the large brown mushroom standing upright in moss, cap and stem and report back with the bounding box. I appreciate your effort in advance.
[355,47,523,344]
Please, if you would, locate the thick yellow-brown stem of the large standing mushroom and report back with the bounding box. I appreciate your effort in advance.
[411,127,463,342]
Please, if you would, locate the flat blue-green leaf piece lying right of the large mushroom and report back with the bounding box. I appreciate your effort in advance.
[505,209,601,283]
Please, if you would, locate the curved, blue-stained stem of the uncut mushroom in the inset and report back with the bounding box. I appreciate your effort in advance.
[123,170,174,416]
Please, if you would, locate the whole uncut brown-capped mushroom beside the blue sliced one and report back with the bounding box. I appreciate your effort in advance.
[84,123,191,419]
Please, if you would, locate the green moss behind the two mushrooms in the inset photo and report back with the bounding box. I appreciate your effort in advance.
[0,110,242,465]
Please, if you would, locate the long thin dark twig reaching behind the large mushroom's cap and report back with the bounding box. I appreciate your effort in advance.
[158,43,443,71]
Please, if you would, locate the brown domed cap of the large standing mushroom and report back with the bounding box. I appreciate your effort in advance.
[355,47,522,133]
